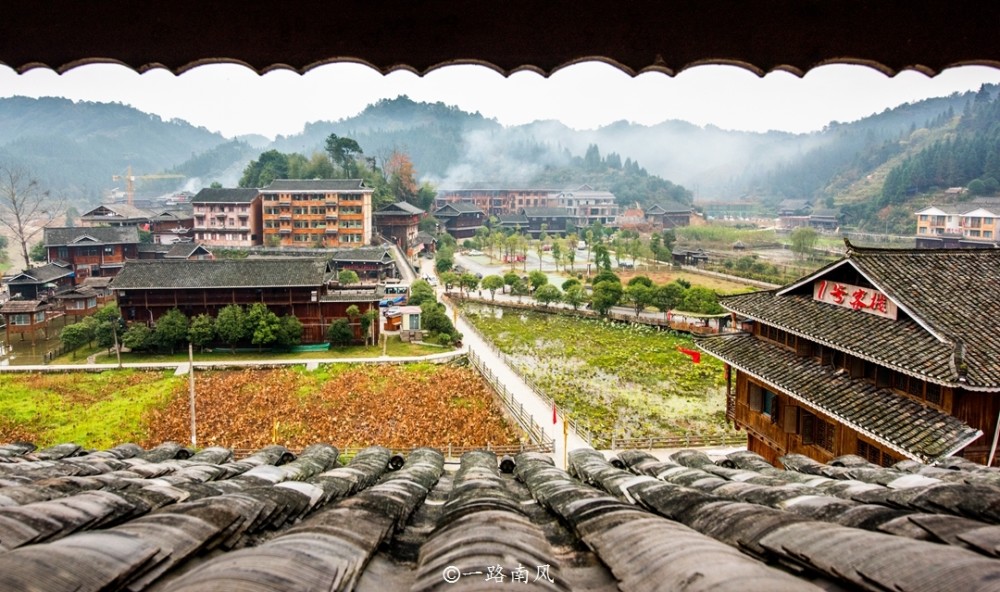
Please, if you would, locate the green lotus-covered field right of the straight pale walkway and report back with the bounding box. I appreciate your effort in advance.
[463,305,729,446]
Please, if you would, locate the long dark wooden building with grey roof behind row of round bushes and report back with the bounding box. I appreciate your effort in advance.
[111,257,382,343]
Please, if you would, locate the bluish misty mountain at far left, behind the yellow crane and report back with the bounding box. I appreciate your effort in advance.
[0,97,226,205]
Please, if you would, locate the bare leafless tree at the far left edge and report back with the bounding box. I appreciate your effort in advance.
[0,163,64,269]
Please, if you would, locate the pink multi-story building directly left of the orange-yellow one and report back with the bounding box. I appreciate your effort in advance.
[191,187,264,247]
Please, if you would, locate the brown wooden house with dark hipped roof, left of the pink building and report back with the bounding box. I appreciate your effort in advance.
[42,226,139,284]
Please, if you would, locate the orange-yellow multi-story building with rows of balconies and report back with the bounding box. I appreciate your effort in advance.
[260,179,372,247]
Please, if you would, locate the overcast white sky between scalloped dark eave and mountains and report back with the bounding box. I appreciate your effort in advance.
[0,62,1000,138]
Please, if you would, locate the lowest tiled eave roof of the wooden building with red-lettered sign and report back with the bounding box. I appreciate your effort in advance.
[697,333,982,461]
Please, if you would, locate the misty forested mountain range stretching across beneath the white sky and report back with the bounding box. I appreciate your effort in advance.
[0,88,995,208]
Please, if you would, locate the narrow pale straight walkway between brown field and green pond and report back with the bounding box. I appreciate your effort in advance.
[421,259,590,468]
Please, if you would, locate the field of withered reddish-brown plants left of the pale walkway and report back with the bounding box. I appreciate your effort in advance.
[140,365,519,449]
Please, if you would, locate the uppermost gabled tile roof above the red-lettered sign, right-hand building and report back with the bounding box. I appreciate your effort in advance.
[778,245,1000,390]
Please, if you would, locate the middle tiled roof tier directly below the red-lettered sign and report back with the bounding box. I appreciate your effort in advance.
[719,290,958,385]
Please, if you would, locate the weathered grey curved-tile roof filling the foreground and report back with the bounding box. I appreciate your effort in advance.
[0,443,1000,592]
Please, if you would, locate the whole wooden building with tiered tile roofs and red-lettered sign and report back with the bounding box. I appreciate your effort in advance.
[698,244,1000,466]
